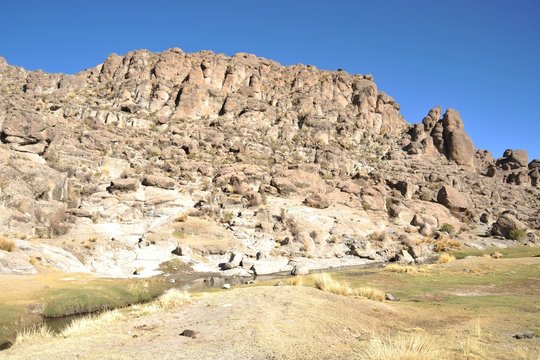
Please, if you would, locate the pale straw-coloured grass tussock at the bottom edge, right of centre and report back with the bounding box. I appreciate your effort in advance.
[362,334,448,360]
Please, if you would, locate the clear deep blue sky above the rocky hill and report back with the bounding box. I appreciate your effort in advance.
[0,0,540,158]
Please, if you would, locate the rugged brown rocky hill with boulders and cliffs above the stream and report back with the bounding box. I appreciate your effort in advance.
[0,49,540,276]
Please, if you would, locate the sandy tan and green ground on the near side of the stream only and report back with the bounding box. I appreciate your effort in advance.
[0,257,540,360]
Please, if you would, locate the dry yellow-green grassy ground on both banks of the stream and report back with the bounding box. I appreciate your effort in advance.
[0,248,540,360]
